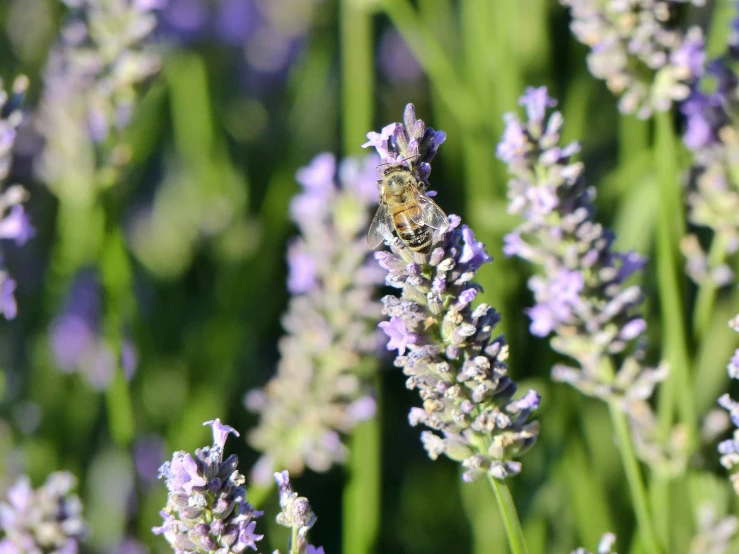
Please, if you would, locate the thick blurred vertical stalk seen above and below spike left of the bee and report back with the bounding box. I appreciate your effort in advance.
[340,5,382,554]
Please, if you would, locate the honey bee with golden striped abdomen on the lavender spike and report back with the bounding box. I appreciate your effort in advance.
[367,163,449,254]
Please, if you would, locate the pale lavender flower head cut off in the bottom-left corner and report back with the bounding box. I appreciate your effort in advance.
[0,471,85,554]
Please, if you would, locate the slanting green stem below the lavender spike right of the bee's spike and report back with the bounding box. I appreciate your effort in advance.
[608,400,661,554]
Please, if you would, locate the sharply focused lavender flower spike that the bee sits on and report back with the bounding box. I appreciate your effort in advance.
[365,105,539,481]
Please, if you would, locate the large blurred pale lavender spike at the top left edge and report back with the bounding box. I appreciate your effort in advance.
[38,0,164,202]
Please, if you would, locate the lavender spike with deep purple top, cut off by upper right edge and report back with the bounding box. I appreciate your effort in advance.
[680,34,739,286]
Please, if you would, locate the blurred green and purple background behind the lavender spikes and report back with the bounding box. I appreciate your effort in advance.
[0,0,737,554]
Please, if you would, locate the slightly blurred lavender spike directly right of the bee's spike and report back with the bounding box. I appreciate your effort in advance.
[498,87,667,462]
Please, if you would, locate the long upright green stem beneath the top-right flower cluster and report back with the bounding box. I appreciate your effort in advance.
[655,112,696,444]
